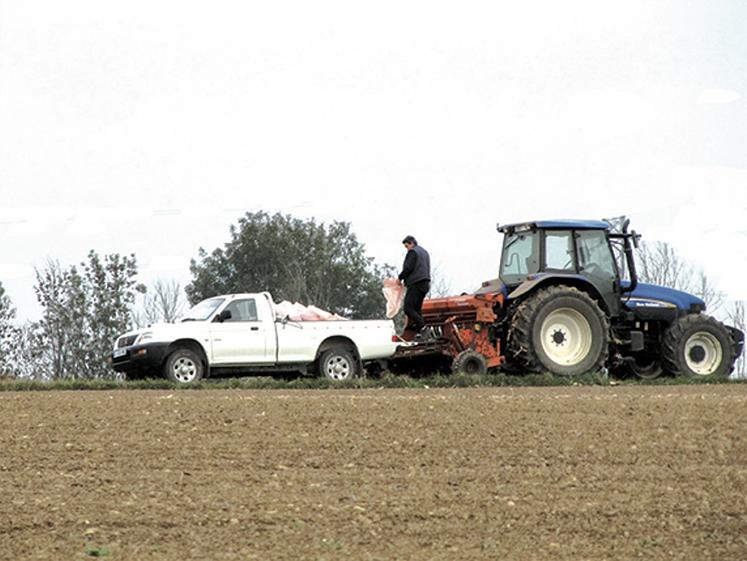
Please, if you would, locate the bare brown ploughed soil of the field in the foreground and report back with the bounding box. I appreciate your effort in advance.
[0,385,747,561]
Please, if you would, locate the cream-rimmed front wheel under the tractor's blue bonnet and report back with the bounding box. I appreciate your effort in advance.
[663,314,734,379]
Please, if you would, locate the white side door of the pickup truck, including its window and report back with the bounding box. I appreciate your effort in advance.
[210,298,275,366]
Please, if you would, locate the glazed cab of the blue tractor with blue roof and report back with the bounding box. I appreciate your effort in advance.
[498,220,624,316]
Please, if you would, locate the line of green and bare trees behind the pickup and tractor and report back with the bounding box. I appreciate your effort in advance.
[0,212,747,380]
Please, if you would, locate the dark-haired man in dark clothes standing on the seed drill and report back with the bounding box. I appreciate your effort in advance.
[399,236,431,340]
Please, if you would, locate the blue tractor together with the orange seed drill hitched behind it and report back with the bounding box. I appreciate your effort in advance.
[395,220,744,379]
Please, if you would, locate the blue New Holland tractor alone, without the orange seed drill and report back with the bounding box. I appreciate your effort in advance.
[498,220,744,379]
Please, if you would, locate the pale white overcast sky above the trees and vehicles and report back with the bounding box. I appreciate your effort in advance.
[0,0,747,319]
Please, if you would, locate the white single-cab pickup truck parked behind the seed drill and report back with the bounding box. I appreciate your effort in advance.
[111,292,397,384]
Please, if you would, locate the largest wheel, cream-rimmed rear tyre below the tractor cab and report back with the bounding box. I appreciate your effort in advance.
[509,286,609,376]
